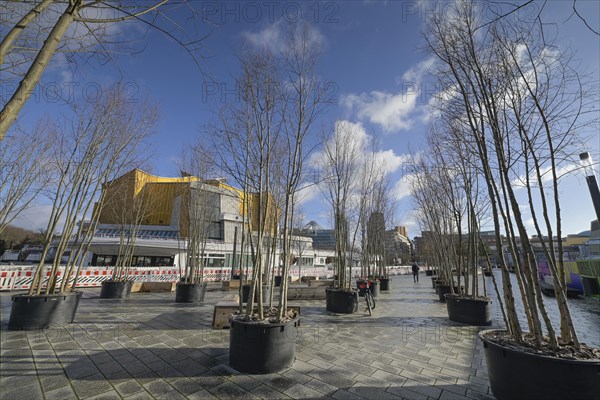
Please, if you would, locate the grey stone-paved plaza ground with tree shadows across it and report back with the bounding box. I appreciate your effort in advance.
[0,276,600,400]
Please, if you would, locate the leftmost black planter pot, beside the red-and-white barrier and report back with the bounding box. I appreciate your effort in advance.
[8,292,82,331]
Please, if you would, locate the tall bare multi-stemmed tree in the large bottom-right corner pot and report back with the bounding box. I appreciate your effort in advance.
[426,1,597,350]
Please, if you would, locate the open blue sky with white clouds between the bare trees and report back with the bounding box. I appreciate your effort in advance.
[9,0,600,236]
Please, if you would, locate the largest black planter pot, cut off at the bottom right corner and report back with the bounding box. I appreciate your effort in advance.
[479,330,600,400]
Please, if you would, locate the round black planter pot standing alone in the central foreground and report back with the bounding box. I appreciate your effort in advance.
[229,318,299,374]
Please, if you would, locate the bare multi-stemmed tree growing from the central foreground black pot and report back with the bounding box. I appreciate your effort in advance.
[213,24,326,321]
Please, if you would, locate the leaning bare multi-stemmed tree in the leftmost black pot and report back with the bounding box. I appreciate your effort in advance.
[29,87,157,295]
